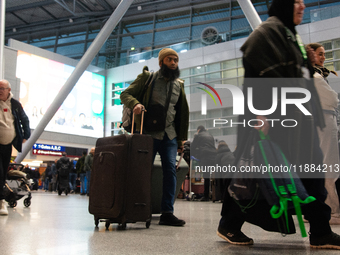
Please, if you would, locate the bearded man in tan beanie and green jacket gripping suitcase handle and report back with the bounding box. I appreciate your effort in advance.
[120,48,189,226]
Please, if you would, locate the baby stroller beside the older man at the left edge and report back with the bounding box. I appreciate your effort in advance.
[4,164,32,208]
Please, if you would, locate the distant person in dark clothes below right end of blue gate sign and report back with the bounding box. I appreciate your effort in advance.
[57,152,72,196]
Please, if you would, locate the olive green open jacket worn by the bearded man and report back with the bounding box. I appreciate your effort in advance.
[120,67,189,146]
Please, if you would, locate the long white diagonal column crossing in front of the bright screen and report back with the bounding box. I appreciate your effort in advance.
[14,0,133,163]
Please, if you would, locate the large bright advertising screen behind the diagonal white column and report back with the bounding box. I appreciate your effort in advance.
[16,51,105,137]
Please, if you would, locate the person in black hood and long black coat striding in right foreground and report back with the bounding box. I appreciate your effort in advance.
[217,0,340,249]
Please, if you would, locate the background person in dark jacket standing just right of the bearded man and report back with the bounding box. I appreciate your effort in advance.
[190,126,216,201]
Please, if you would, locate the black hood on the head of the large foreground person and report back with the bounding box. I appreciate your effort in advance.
[268,0,296,34]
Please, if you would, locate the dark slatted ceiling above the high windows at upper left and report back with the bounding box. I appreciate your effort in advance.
[5,0,229,41]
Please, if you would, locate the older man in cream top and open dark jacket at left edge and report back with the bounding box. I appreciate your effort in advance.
[0,80,31,215]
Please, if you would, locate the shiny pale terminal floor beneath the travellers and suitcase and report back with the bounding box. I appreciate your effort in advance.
[0,192,340,255]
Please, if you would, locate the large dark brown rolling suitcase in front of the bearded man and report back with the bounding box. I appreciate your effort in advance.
[89,114,153,229]
